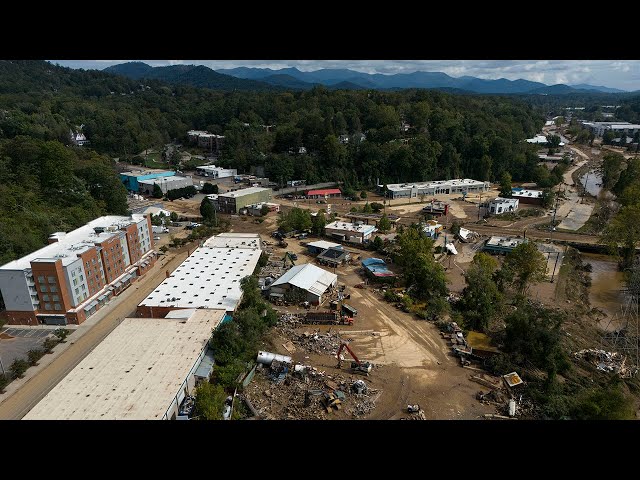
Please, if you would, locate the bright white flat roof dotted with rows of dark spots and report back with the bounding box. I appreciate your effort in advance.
[140,246,262,311]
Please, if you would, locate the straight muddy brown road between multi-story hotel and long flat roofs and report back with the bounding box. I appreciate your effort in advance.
[0,251,187,420]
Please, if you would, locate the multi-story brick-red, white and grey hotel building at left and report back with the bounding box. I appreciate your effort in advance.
[0,214,155,325]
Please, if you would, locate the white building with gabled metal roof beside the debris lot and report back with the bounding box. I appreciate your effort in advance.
[269,263,338,305]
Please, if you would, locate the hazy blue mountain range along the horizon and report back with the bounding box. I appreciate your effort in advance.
[104,62,624,95]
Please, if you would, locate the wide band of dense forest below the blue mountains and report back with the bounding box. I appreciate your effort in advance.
[0,61,545,186]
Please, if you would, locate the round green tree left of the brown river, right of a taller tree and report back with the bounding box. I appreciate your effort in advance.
[502,242,547,295]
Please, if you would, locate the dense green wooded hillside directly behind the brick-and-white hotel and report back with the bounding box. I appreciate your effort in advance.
[0,136,127,265]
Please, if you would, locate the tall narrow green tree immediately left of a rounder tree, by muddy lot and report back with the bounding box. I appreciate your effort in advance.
[458,253,503,331]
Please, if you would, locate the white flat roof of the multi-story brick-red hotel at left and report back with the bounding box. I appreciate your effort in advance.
[0,213,145,270]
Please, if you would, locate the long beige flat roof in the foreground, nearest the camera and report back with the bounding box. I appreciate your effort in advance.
[24,309,225,420]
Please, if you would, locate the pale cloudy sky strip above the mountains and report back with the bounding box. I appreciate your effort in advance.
[50,60,640,91]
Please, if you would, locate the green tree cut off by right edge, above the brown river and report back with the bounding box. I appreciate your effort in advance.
[601,204,640,268]
